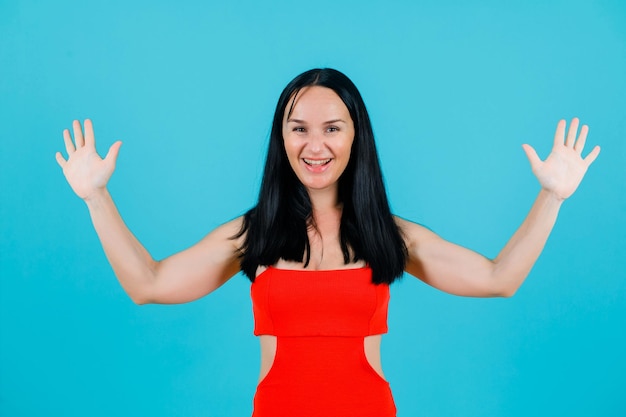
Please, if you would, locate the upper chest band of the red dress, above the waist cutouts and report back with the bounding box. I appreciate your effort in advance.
[250,267,389,337]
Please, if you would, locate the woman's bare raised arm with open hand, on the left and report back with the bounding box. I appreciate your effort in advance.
[56,120,241,304]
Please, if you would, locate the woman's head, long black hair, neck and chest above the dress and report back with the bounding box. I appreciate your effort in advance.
[239,69,406,283]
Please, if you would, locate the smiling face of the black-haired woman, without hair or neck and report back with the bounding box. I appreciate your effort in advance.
[283,86,354,197]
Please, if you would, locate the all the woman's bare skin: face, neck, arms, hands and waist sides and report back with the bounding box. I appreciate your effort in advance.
[56,87,600,379]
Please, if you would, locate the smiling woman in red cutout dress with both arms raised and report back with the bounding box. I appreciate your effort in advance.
[56,69,600,417]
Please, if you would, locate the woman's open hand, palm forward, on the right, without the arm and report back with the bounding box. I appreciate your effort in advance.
[522,118,600,200]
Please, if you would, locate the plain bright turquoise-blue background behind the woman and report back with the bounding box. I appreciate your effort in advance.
[0,0,626,417]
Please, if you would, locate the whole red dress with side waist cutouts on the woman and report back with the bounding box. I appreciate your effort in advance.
[251,267,396,417]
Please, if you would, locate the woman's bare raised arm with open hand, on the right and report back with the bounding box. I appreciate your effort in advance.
[397,119,600,297]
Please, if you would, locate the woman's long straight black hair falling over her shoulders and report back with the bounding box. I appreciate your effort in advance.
[237,68,407,284]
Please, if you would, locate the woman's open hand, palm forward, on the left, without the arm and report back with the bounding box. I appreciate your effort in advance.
[56,119,122,201]
